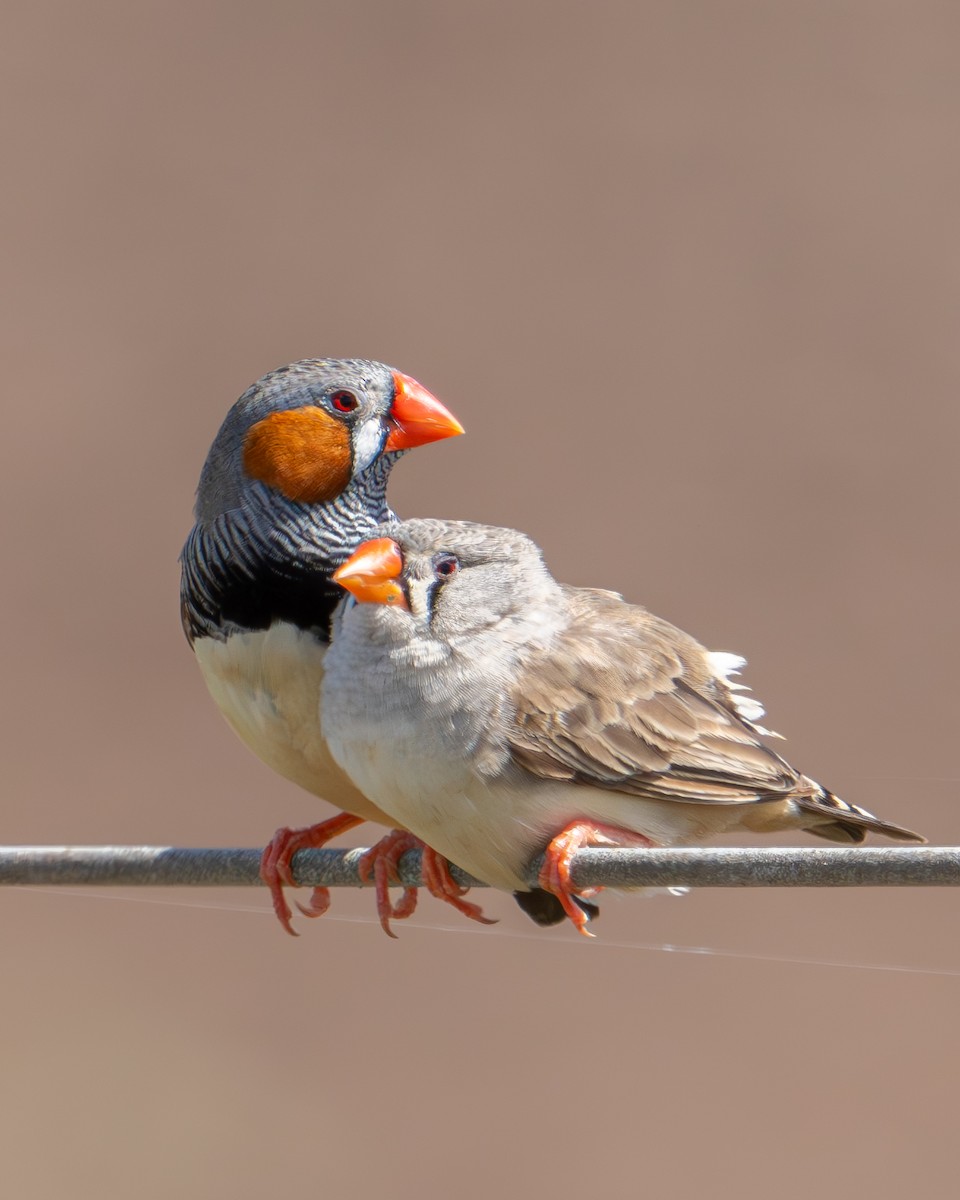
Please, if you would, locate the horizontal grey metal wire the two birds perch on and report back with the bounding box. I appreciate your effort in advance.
[0,846,960,889]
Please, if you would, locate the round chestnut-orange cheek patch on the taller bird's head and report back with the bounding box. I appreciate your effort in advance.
[244,408,350,504]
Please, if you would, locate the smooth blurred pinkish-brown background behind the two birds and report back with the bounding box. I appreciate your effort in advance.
[0,0,960,1200]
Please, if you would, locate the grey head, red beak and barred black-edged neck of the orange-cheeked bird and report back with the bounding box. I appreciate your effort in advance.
[181,359,463,642]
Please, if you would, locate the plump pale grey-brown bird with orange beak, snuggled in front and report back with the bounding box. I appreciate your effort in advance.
[323,521,923,932]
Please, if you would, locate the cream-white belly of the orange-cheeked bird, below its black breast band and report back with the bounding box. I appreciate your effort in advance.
[193,622,394,826]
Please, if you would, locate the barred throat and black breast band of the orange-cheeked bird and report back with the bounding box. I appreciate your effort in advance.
[181,455,395,642]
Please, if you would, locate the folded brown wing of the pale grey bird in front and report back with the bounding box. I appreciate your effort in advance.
[508,588,801,804]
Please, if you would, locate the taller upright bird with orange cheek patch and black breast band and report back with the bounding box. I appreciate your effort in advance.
[181,359,475,932]
